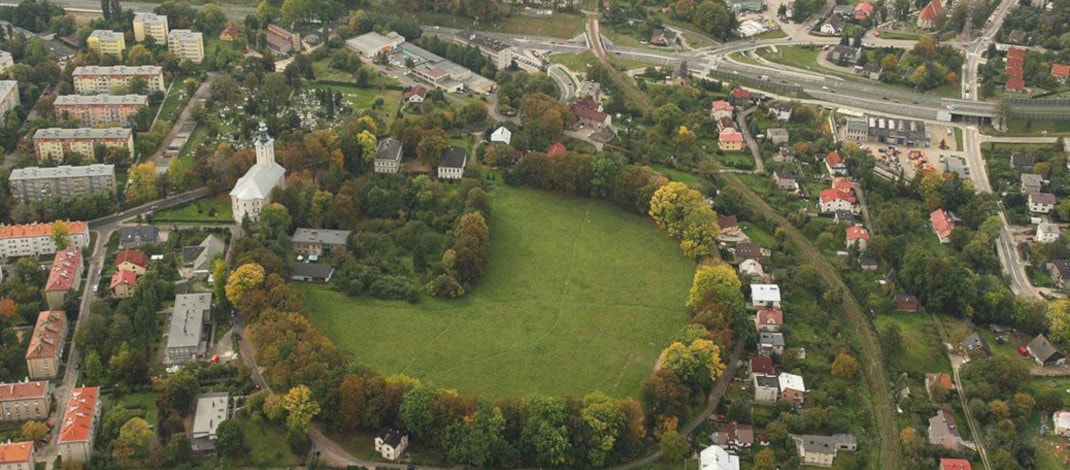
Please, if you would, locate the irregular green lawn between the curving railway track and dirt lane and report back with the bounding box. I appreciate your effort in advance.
[875,312,951,376]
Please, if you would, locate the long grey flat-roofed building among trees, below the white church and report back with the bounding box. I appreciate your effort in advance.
[164,293,212,365]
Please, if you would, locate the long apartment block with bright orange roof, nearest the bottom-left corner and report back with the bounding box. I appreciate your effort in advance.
[57,386,101,463]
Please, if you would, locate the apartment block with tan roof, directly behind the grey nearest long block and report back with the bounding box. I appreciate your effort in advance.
[33,127,134,162]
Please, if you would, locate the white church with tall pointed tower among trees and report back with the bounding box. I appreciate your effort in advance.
[230,121,286,224]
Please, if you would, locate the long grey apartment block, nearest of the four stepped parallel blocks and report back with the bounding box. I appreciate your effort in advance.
[9,164,116,202]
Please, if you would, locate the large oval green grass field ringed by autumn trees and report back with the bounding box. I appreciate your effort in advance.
[300,186,693,397]
